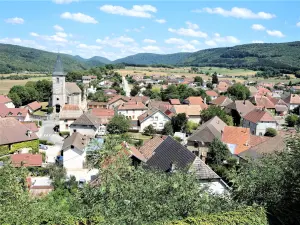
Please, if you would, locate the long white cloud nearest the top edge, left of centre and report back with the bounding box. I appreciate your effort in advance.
[100,5,157,18]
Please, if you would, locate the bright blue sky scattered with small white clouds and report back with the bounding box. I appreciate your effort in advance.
[0,0,300,59]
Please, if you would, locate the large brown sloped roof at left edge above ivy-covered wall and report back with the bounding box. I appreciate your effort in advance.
[0,117,38,145]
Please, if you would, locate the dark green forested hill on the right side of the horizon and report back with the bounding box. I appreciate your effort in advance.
[182,41,300,72]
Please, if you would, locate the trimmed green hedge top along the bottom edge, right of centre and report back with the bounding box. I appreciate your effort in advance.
[168,207,269,225]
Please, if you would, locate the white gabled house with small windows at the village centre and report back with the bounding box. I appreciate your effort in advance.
[138,108,171,132]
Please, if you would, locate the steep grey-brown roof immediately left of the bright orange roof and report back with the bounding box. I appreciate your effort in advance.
[188,116,226,143]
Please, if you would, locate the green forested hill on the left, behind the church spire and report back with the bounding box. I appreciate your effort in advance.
[0,44,108,73]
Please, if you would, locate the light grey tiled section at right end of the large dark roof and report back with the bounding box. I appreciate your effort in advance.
[189,157,221,180]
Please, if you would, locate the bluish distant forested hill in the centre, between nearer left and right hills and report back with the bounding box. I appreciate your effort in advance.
[114,52,191,65]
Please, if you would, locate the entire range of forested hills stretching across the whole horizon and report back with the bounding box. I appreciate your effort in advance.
[0,41,300,73]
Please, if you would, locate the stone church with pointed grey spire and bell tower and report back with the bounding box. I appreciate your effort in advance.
[52,55,82,113]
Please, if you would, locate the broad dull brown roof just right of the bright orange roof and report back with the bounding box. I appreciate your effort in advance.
[238,134,286,160]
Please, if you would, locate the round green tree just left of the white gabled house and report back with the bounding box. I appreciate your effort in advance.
[107,115,131,134]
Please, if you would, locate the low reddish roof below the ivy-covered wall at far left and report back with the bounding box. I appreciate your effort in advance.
[10,153,43,167]
